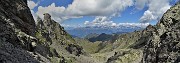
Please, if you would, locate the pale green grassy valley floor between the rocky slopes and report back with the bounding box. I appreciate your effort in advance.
[76,32,145,63]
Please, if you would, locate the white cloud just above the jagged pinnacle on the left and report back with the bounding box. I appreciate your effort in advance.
[28,1,70,23]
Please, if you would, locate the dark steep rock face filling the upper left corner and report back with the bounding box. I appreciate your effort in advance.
[0,0,35,35]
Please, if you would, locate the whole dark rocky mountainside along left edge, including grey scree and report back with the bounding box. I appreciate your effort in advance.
[0,0,39,63]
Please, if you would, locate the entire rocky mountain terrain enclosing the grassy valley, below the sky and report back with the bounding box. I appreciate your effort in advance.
[0,0,180,63]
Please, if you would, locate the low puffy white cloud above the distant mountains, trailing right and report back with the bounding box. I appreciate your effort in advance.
[84,16,149,28]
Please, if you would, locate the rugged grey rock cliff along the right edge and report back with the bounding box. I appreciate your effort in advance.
[143,3,180,63]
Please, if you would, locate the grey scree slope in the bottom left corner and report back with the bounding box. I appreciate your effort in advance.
[0,41,39,63]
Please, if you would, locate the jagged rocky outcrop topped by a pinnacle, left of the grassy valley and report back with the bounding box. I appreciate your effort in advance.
[34,13,84,62]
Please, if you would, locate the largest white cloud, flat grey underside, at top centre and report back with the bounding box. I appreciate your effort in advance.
[66,0,133,16]
